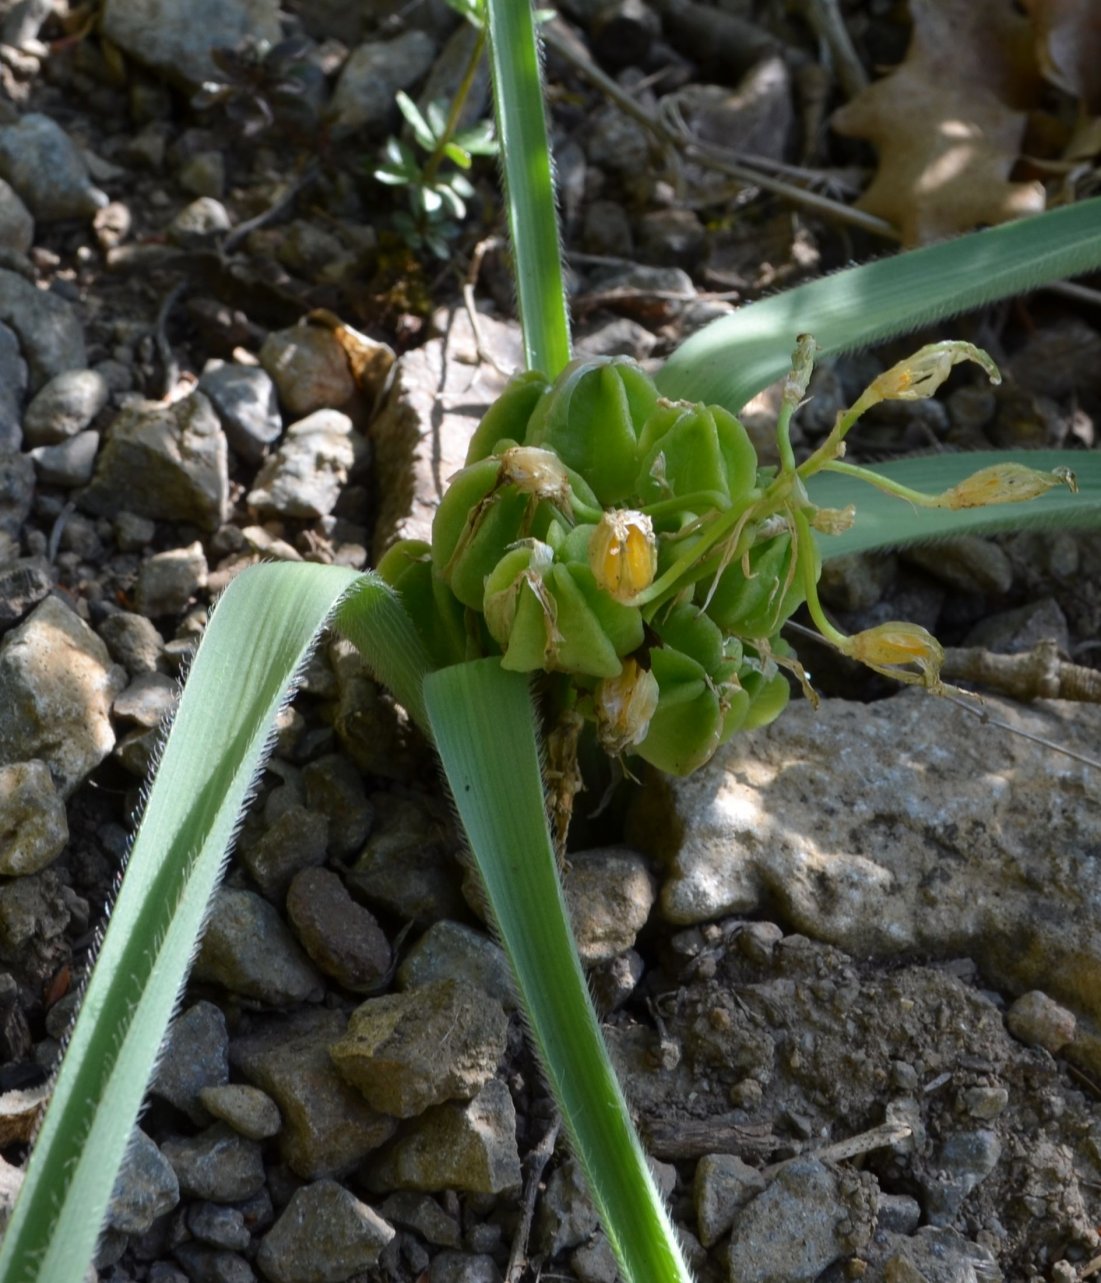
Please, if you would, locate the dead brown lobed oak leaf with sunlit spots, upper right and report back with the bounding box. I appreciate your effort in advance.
[832,0,1045,245]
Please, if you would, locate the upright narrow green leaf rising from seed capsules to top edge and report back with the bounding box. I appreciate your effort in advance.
[486,0,570,378]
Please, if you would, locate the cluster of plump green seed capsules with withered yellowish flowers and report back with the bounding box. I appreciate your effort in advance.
[379,339,1065,775]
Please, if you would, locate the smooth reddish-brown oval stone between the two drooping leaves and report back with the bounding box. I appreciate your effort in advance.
[286,869,390,993]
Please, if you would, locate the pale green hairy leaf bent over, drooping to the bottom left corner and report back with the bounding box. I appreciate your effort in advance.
[0,565,416,1283]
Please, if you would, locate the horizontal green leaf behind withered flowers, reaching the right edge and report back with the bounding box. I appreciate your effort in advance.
[807,450,1101,559]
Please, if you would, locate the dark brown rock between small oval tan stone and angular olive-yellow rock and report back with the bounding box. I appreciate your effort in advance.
[230,1010,397,1180]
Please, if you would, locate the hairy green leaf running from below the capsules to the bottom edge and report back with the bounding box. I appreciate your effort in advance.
[425,659,690,1283]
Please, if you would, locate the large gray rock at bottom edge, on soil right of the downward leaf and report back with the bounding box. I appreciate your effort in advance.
[730,1159,871,1283]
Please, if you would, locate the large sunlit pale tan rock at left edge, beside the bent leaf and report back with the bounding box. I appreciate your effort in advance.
[0,597,126,798]
